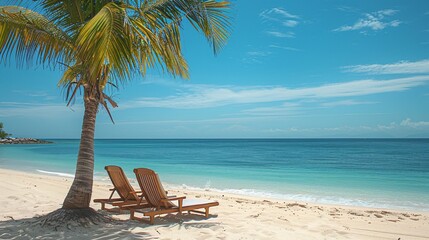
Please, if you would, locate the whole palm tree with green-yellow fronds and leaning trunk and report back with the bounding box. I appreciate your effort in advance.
[0,0,230,225]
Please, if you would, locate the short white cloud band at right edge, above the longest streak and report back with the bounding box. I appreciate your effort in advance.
[343,59,429,74]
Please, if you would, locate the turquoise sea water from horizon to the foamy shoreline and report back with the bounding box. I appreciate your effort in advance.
[0,139,429,211]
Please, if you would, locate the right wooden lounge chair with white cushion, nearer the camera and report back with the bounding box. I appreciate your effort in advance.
[130,168,219,224]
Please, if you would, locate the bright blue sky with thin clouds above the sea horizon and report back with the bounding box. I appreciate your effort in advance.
[0,0,429,138]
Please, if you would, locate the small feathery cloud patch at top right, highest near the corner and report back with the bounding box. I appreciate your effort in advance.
[334,9,402,32]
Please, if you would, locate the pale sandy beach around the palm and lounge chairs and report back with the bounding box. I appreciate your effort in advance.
[0,169,429,240]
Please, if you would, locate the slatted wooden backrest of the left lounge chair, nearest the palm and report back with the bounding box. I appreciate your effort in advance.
[104,166,139,201]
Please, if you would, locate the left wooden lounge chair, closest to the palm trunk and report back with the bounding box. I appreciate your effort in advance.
[94,166,147,211]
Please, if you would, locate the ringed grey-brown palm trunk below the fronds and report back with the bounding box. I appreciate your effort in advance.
[63,98,98,209]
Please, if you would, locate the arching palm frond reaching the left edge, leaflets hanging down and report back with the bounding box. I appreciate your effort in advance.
[0,6,73,66]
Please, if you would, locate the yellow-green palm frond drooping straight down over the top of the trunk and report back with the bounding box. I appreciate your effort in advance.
[76,2,138,81]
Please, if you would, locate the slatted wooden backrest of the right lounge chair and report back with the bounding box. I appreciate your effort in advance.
[134,168,176,208]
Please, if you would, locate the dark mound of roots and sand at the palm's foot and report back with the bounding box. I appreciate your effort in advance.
[34,208,113,231]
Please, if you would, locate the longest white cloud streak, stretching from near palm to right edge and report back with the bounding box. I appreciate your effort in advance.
[121,76,429,109]
